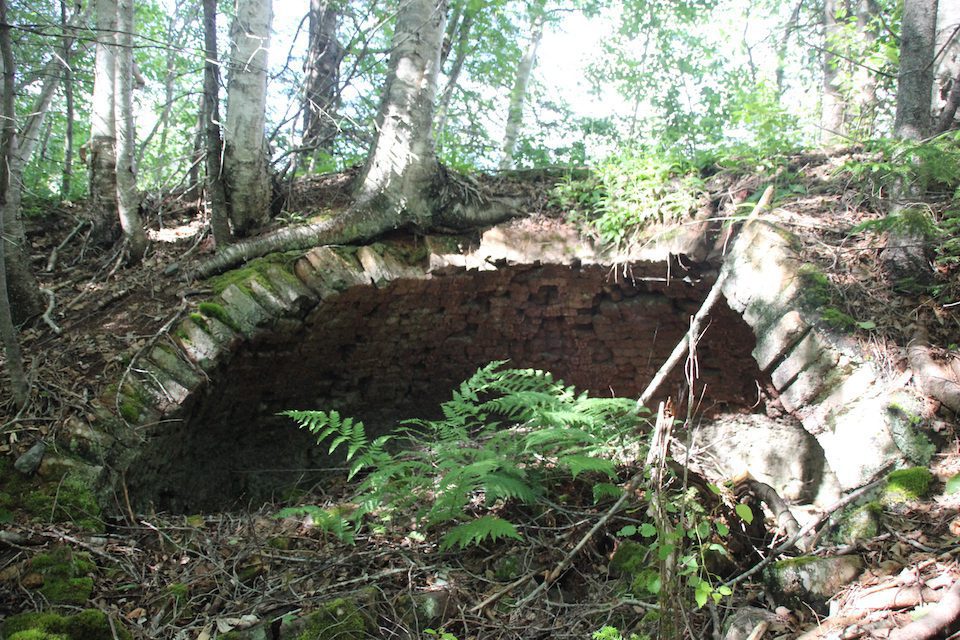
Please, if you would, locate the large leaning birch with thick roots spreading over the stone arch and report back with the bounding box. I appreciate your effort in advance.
[190,0,516,278]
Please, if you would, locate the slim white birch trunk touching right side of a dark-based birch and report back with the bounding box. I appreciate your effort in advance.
[114,0,147,264]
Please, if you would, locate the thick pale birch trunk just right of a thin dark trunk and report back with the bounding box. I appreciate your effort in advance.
[223,0,273,236]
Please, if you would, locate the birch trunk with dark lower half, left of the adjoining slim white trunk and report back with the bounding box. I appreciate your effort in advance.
[87,0,119,246]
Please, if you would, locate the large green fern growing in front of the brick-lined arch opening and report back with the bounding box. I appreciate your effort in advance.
[283,362,643,548]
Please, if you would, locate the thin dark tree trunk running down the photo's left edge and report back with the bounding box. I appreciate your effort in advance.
[0,0,30,408]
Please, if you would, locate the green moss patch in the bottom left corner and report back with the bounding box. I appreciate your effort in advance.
[0,609,132,640]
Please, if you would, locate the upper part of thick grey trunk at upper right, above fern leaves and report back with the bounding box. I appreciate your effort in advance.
[893,0,937,140]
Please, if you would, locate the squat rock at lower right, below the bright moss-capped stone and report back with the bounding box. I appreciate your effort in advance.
[763,556,863,615]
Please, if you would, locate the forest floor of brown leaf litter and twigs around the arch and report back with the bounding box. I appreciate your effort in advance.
[0,155,960,640]
